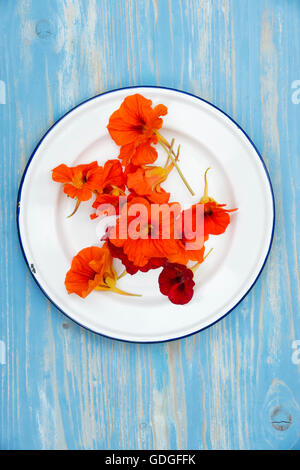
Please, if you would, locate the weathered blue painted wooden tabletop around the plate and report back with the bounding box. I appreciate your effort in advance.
[0,0,300,449]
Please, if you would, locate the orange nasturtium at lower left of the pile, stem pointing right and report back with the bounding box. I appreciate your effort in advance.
[65,243,138,298]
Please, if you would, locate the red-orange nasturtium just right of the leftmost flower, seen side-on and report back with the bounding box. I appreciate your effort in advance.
[90,160,126,219]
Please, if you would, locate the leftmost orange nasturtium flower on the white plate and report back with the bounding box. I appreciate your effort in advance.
[52,162,101,201]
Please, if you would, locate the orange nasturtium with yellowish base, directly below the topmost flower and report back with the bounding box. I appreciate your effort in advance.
[127,163,173,204]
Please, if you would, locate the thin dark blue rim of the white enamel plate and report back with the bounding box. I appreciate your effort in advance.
[16,85,275,344]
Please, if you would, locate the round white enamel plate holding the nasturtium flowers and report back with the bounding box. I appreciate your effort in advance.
[17,87,274,342]
